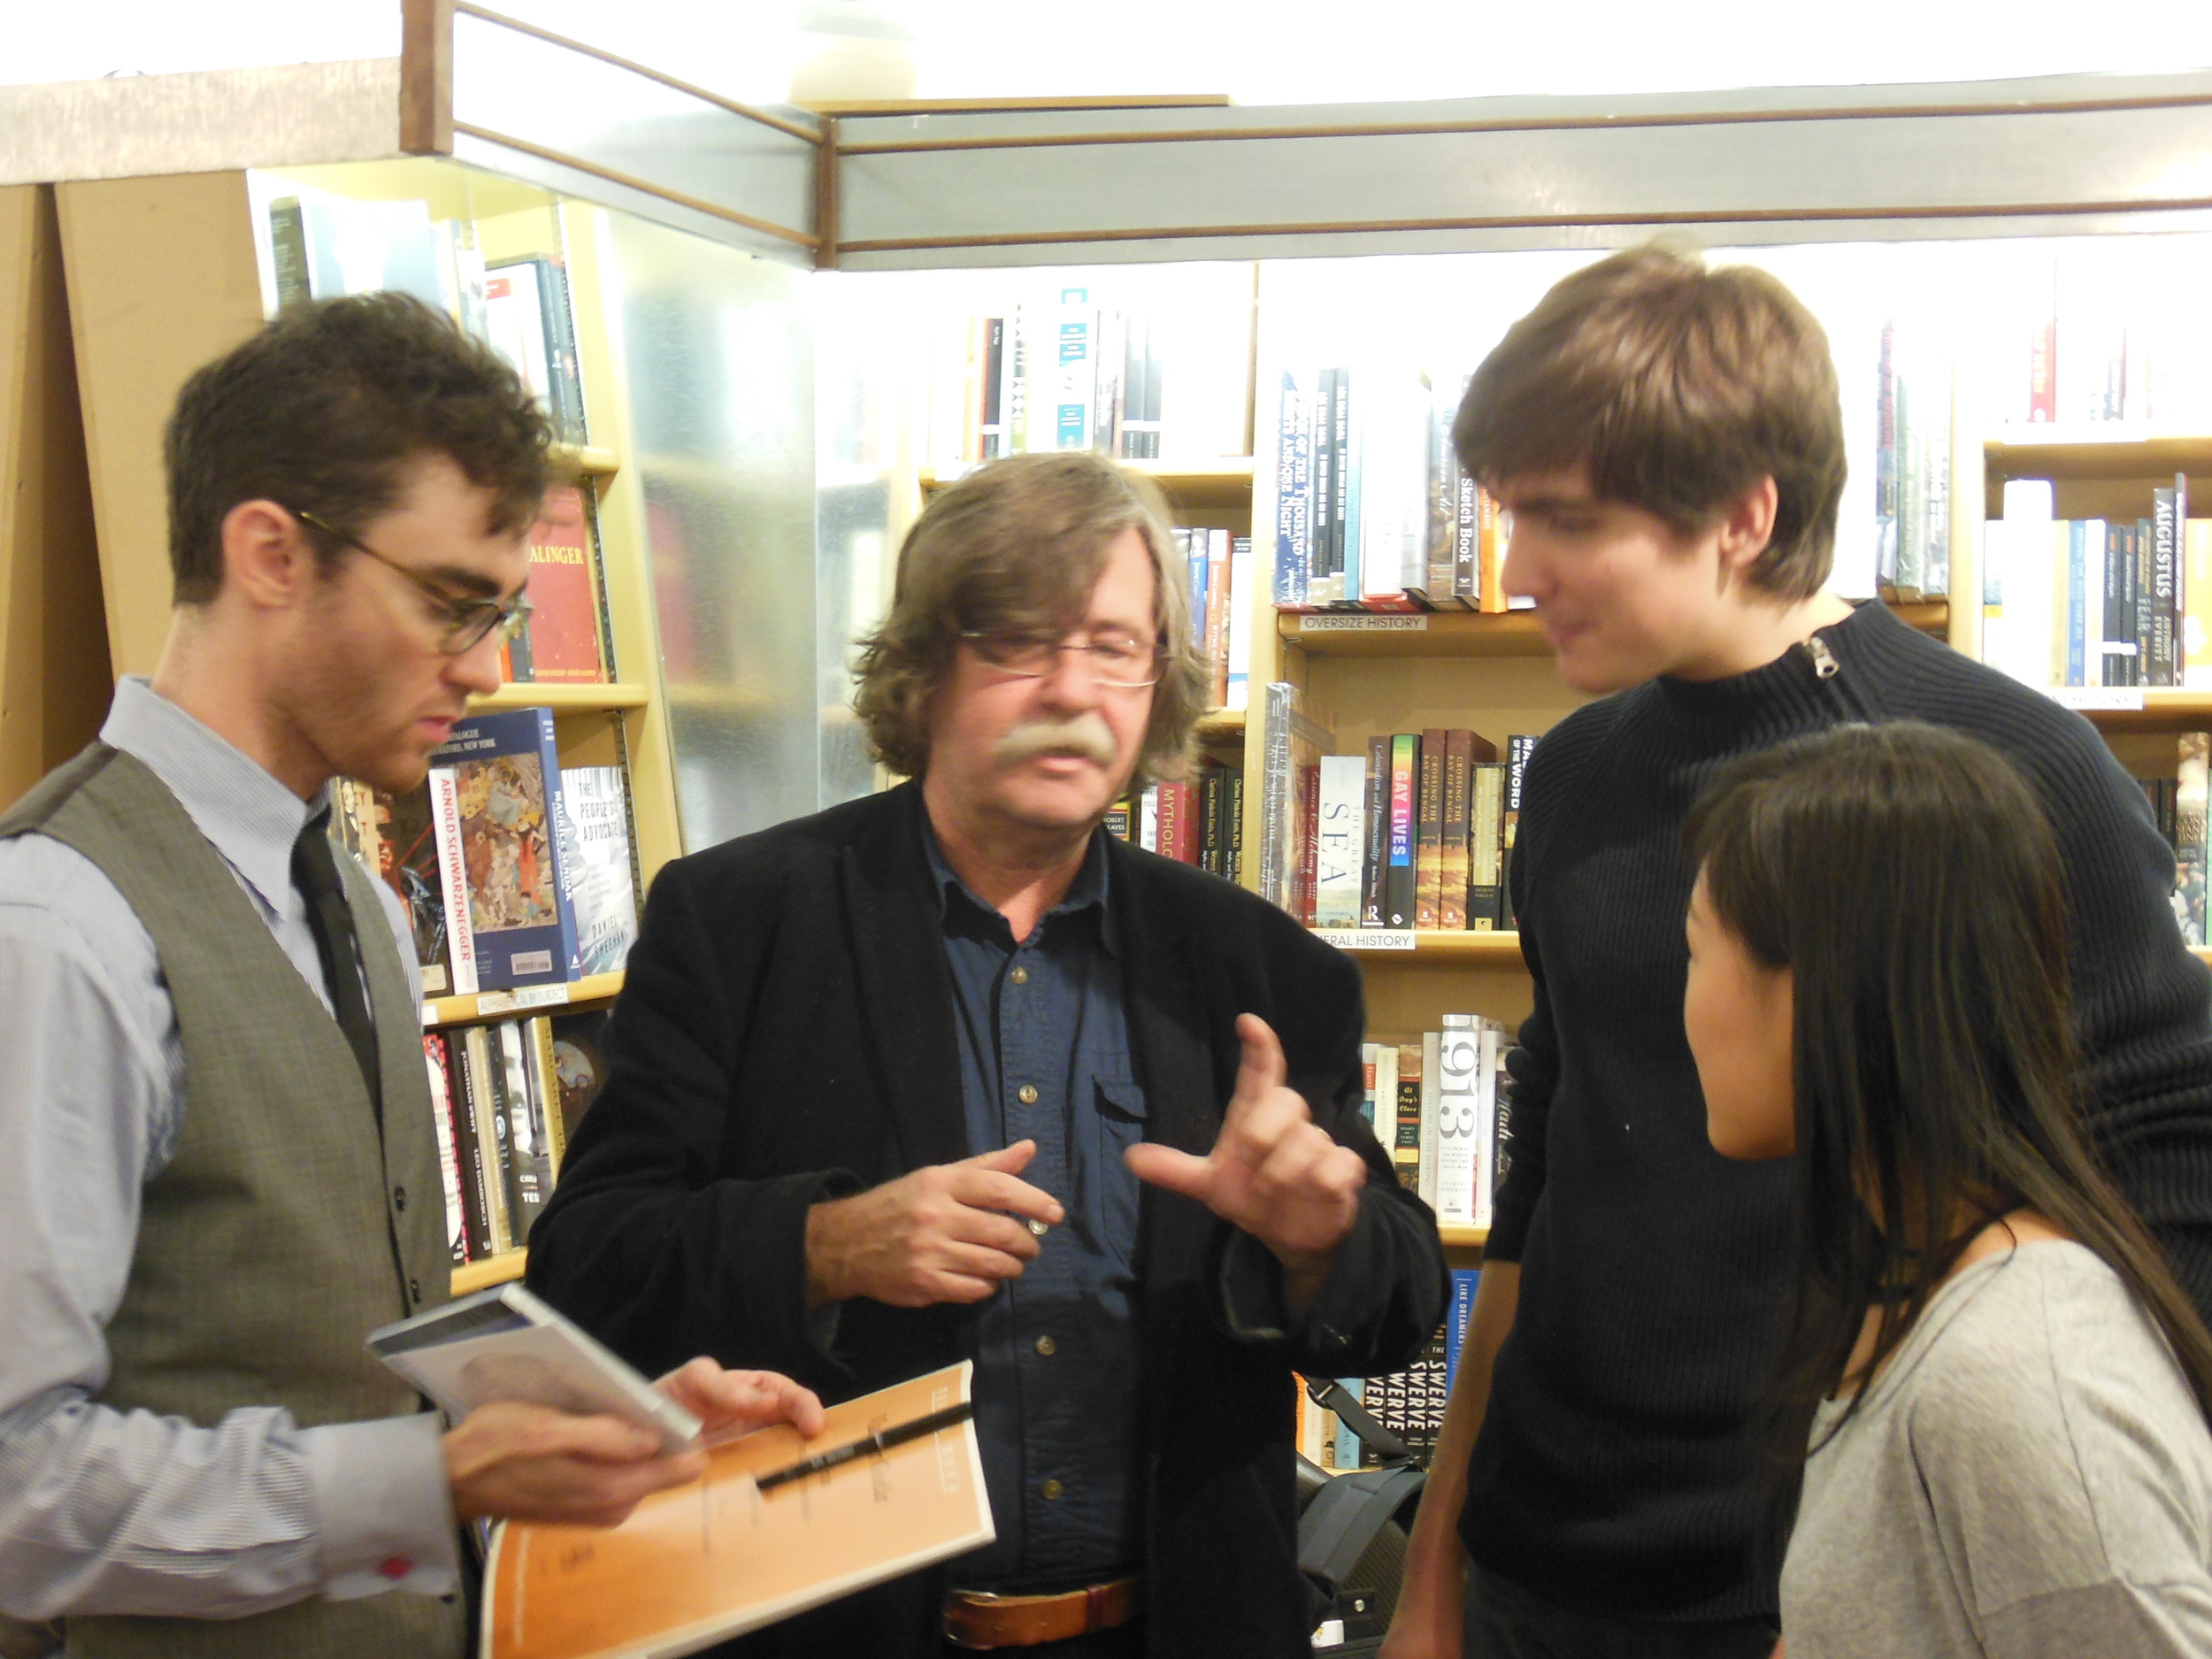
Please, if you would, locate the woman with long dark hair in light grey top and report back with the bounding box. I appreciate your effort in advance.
[1684,724,2212,1659]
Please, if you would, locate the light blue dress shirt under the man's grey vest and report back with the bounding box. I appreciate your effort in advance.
[0,680,458,1619]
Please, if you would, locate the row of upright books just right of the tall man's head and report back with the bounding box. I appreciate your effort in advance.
[1874,321,1951,600]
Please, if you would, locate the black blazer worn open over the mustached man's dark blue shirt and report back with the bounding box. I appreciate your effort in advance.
[529,783,1449,1659]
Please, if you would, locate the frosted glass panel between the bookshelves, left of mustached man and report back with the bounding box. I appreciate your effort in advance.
[609,215,823,852]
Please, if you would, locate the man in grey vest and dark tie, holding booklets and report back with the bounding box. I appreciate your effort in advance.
[0,295,821,1659]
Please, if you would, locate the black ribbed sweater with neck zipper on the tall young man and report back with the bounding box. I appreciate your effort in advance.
[1460,604,2212,1619]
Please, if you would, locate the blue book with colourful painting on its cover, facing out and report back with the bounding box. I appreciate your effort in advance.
[429,708,578,995]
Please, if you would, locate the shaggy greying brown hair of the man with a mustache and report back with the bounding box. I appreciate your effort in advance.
[852,449,1208,790]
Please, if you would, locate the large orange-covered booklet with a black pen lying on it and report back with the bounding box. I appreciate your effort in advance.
[495,1363,995,1659]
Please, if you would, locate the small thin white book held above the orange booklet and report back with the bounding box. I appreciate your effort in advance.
[370,1286,702,1451]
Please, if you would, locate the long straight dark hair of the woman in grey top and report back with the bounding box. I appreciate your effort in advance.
[1686,721,2212,1495]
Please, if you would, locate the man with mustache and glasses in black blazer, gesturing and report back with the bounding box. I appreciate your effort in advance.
[531,454,1447,1659]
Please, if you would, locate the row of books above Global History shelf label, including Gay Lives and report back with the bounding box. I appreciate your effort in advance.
[1263,728,1535,933]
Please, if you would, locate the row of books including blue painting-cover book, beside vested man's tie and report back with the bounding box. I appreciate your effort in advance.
[332,708,637,995]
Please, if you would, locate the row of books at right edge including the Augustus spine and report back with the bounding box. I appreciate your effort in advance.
[1982,473,2212,688]
